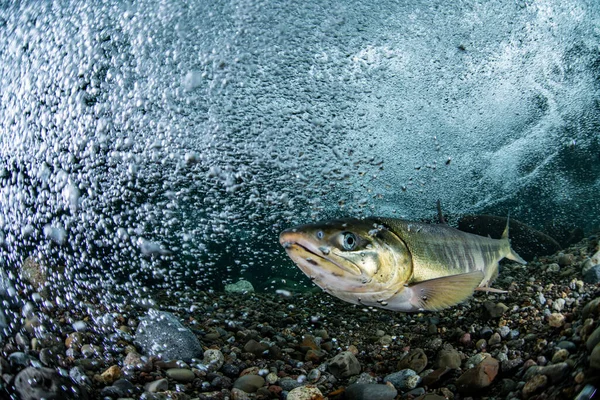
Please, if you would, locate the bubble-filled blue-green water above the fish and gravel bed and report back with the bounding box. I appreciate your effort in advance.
[0,0,600,320]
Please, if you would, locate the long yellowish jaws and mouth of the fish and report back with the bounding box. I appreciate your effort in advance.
[279,230,362,276]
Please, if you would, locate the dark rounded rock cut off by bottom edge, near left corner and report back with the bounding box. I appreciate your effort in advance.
[14,367,87,400]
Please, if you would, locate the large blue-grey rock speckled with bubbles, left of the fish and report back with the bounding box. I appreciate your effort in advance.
[135,310,203,360]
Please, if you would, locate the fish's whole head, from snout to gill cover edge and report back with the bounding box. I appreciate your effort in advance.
[279,219,412,305]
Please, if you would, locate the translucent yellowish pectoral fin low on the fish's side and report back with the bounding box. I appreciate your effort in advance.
[405,271,484,311]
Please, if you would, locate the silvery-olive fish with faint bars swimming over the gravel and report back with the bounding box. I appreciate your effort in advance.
[279,217,526,312]
